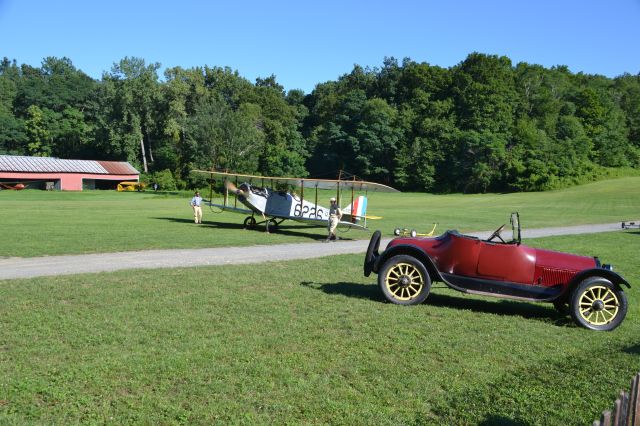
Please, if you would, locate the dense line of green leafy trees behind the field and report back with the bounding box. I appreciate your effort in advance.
[0,53,640,192]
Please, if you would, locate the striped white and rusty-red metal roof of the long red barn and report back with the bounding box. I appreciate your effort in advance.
[0,155,139,175]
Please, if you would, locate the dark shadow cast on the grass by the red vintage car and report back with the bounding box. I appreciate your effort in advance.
[300,281,573,327]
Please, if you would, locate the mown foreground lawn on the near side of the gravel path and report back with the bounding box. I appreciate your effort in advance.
[0,231,640,425]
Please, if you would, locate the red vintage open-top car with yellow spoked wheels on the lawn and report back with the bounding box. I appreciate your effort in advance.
[364,213,630,330]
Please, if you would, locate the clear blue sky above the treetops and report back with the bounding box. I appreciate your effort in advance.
[0,0,640,93]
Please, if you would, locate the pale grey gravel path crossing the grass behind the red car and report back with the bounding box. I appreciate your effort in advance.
[0,222,621,280]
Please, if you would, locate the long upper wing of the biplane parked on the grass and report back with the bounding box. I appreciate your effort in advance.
[193,170,400,192]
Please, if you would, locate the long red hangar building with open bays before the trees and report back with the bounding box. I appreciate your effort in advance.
[0,155,140,191]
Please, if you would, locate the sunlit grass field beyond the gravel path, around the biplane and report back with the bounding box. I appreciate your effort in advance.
[0,177,640,257]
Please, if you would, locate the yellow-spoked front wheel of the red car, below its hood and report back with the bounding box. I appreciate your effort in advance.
[571,277,627,331]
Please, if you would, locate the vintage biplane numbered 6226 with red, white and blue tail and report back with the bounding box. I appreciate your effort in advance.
[193,170,399,232]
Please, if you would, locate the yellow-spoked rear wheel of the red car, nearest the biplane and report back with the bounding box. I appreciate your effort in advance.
[378,254,431,305]
